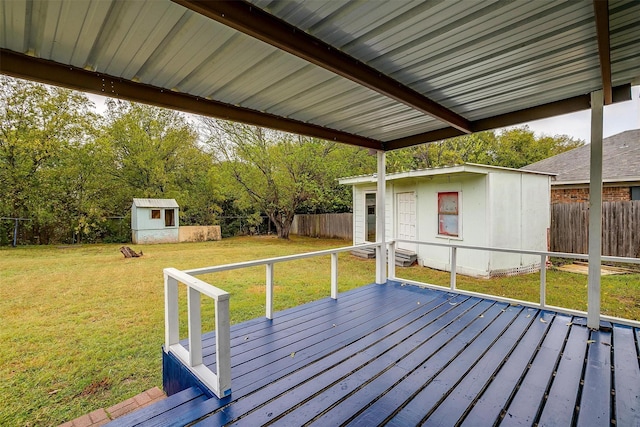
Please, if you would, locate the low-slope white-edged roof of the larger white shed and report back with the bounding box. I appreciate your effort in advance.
[339,163,554,185]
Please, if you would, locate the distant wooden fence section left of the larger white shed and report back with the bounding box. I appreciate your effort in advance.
[291,213,353,240]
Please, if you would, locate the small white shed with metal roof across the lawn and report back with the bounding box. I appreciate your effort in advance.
[131,199,179,244]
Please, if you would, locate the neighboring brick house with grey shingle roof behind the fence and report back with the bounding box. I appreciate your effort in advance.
[522,129,640,203]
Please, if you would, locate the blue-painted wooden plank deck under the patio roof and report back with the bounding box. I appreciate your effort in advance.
[112,283,640,426]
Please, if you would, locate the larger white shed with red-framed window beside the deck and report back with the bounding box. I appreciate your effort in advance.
[340,163,551,277]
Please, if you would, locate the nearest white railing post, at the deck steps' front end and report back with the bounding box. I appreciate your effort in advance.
[215,294,231,396]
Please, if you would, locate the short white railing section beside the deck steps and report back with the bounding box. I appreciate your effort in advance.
[164,268,231,398]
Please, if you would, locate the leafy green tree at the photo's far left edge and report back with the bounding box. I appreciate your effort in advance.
[0,77,97,242]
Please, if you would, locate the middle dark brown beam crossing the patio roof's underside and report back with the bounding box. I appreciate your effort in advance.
[173,0,471,133]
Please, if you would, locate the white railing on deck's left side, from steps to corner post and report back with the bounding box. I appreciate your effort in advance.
[164,243,382,398]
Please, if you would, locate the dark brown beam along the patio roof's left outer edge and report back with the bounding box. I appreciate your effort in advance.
[0,49,383,150]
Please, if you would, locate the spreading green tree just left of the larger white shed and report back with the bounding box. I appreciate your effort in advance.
[201,117,374,239]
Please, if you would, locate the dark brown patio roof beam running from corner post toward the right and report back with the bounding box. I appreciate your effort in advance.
[384,84,631,150]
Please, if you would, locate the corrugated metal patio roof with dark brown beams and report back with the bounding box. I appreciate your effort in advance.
[0,0,640,150]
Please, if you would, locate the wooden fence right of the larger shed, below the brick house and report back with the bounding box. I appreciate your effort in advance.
[550,200,640,258]
